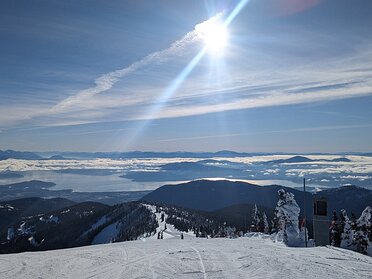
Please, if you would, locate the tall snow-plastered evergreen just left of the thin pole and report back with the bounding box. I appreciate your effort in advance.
[276,189,303,246]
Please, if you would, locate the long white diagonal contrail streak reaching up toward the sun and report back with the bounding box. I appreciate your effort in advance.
[49,13,223,113]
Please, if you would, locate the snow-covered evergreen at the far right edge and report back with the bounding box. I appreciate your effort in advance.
[353,206,372,254]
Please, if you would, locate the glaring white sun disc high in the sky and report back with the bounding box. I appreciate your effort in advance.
[200,22,228,53]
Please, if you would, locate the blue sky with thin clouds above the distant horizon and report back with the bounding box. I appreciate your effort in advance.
[0,0,372,153]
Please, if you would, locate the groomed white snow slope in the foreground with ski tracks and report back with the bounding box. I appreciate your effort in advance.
[0,237,372,279]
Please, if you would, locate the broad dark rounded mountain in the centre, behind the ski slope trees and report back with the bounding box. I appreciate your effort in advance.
[142,180,312,211]
